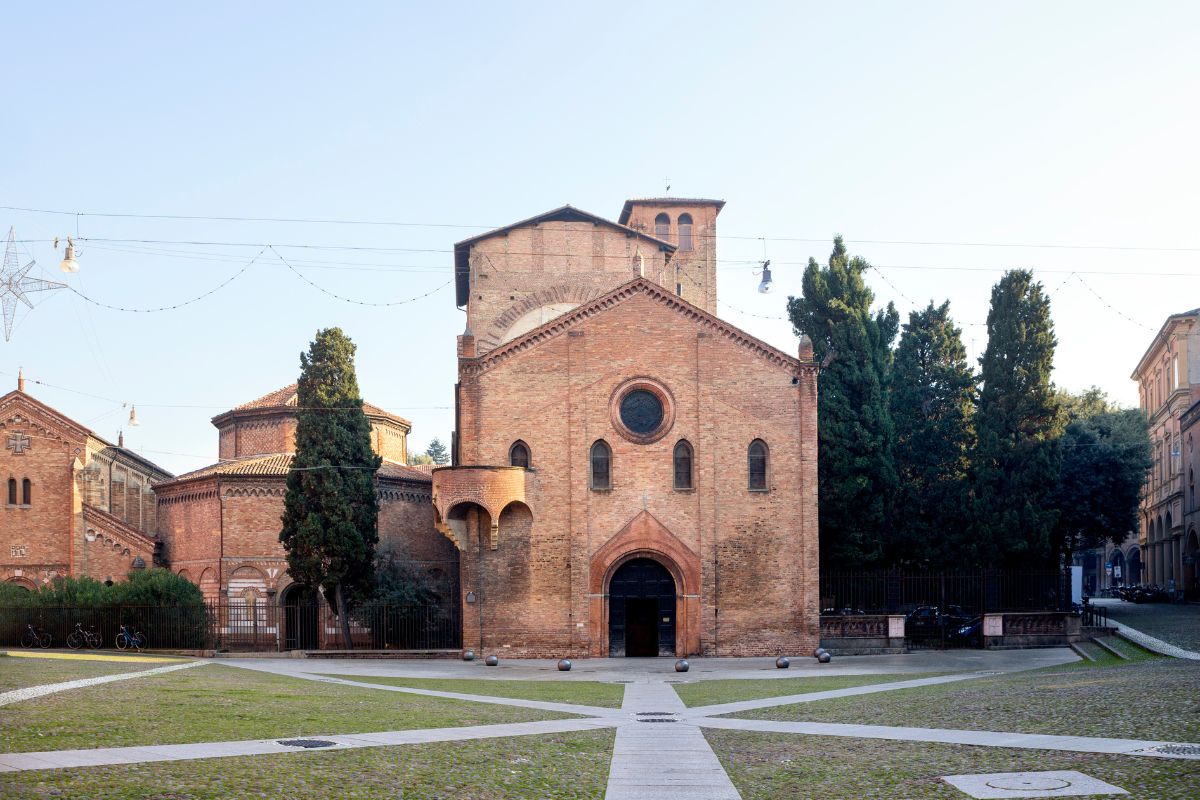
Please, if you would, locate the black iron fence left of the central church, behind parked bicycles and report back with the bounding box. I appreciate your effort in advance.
[0,601,462,650]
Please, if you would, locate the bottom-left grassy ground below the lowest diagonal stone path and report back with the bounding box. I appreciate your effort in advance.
[0,734,613,800]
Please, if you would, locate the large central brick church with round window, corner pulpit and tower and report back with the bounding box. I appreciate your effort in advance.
[433,198,818,656]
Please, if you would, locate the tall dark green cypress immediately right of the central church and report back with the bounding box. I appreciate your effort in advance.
[787,236,900,569]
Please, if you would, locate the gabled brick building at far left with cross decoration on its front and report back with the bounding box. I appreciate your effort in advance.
[0,369,172,589]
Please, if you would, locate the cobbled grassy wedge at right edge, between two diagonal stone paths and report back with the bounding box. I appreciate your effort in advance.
[737,658,1200,743]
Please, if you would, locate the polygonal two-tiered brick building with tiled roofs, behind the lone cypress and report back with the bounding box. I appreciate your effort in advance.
[156,384,458,646]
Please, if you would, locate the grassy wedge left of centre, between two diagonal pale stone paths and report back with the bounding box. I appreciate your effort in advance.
[0,664,571,752]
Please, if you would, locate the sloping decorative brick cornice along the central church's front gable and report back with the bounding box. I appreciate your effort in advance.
[464,277,812,374]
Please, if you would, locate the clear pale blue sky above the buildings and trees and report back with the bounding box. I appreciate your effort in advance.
[0,2,1200,471]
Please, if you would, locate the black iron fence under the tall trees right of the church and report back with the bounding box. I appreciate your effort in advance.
[821,570,1069,615]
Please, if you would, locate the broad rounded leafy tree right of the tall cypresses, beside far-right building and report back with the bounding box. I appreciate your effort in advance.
[1052,389,1153,564]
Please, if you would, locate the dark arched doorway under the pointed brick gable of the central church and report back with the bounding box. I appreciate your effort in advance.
[608,558,676,656]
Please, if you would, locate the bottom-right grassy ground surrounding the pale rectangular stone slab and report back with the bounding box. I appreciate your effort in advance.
[704,730,1200,800]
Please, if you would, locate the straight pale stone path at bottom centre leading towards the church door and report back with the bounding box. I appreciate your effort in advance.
[605,682,742,800]
